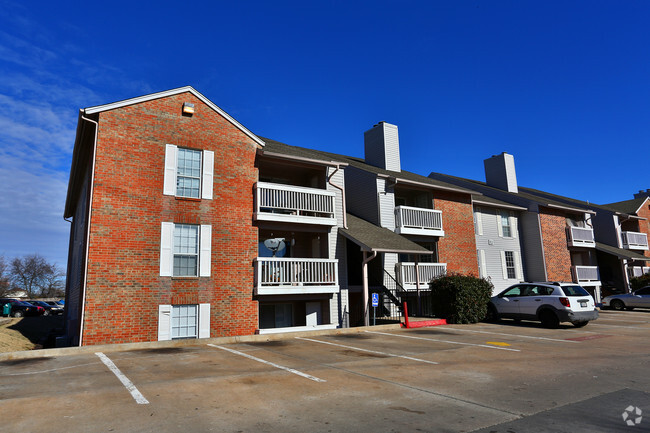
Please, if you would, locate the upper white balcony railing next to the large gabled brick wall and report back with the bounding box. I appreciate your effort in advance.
[255,182,336,226]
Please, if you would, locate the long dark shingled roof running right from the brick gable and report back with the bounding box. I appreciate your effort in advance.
[260,137,480,195]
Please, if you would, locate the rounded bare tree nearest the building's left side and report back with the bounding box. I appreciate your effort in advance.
[11,254,63,298]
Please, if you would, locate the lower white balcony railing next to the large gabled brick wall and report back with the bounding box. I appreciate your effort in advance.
[255,257,339,295]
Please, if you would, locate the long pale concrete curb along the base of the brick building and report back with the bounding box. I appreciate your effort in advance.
[0,323,402,362]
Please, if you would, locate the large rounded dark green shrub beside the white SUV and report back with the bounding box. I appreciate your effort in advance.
[429,274,493,323]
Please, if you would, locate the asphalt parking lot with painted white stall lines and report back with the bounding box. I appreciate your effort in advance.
[0,310,650,433]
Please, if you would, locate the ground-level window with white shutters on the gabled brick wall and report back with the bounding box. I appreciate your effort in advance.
[158,304,210,341]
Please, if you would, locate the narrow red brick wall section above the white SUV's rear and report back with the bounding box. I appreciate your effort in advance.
[539,207,573,281]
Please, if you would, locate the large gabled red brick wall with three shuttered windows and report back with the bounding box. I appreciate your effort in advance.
[83,93,258,345]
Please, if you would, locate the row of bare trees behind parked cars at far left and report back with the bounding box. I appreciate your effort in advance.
[0,254,65,299]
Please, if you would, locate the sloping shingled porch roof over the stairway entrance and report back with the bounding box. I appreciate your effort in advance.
[339,214,433,254]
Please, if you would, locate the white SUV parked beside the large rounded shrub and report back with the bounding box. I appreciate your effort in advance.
[486,283,598,328]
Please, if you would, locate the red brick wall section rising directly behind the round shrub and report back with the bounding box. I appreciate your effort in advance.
[434,191,478,276]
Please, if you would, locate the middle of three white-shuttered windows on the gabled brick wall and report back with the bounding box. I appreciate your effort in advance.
[160,222,212,277]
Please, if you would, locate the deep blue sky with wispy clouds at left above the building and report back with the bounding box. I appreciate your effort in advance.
[0,0,650,267]
